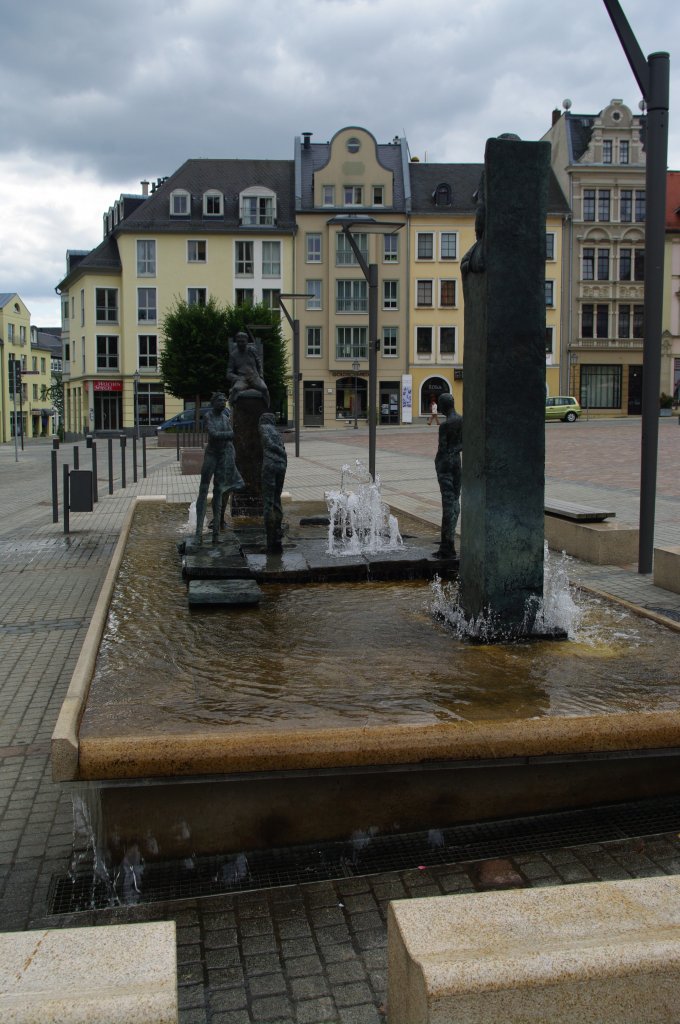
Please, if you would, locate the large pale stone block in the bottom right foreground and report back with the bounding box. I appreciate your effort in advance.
[387,877,680,1024]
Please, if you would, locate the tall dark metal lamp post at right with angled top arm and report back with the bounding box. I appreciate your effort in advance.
[604,0,670,572]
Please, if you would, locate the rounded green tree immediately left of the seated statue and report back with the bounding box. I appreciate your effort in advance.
[161,298,229,404]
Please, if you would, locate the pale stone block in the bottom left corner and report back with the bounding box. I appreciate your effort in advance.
[0,921,178,1024]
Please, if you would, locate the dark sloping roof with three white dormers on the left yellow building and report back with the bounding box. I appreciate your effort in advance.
[114,160,295,233]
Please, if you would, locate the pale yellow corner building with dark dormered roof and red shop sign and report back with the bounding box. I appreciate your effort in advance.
[58,160,295,433]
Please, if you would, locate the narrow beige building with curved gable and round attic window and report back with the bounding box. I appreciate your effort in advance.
[291,127,410,426]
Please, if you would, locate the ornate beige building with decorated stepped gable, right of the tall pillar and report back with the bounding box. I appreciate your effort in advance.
[544,99,646,415]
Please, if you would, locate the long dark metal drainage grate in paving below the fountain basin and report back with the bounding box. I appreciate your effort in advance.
[48,798,680,914]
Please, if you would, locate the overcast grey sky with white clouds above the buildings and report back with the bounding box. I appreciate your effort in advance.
[0,0,680,327]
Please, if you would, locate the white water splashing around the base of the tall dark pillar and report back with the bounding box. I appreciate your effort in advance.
[429,544,583,642]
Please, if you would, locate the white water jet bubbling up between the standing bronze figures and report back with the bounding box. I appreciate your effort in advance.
[326,459,403,555]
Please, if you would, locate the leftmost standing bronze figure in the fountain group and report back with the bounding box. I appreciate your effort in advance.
[196,391,245,544]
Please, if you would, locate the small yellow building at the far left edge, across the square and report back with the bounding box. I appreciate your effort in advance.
[0,292,54,442]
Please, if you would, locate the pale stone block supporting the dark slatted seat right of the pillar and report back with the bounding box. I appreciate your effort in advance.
[545,515,639,565]
